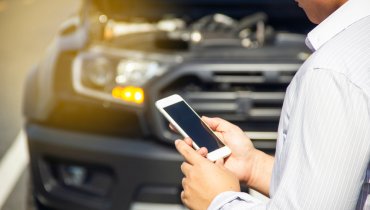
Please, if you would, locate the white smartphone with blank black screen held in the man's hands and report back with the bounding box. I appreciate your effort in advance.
[155,94,231,161]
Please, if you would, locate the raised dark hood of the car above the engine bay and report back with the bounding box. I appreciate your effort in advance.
[87,0,311,33]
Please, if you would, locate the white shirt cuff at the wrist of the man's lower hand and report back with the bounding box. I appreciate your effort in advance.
[208,191,262,210]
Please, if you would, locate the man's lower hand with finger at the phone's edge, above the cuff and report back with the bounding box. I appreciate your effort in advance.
[175,140,240,210]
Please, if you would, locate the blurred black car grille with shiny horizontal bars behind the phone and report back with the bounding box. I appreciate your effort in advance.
[149,63,300,149]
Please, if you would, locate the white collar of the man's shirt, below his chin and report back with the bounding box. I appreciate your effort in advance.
[306,0,370,51]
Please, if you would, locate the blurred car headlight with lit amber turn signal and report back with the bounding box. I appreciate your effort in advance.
[72,47,169,107]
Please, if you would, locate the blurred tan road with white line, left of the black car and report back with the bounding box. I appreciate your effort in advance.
[0,0,80,210]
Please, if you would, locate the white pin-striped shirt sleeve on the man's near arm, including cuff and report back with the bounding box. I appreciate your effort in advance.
[209,69,370,210]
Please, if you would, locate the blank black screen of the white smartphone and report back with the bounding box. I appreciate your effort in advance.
[164,101,224,152]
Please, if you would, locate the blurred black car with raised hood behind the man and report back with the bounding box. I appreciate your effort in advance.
[24,0,311,210]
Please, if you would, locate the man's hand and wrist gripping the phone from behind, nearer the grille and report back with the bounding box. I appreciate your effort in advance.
[178,117,274,196]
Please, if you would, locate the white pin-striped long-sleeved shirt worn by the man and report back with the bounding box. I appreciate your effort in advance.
[208,0,370,210]
